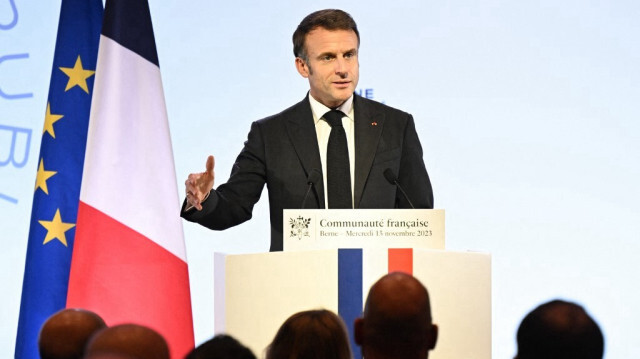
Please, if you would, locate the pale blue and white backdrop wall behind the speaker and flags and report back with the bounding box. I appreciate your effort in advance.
[0,0,640,358]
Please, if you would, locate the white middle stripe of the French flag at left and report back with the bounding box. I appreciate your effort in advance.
[80,36,186,261]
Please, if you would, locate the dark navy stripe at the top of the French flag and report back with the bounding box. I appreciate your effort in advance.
[102,0,160,66]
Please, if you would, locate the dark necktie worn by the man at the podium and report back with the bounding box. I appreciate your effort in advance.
[323,110,353,208]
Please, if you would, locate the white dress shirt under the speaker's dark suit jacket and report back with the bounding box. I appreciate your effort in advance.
[309,94,356,208]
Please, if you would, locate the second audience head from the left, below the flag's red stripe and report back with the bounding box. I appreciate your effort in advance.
[86,324,169,359]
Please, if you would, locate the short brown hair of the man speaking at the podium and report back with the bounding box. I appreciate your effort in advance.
[293,9,360,61]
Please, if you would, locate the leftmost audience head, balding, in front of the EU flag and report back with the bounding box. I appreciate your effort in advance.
[38,309,107,359]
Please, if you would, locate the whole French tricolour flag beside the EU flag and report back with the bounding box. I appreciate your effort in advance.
[67,0,194,358]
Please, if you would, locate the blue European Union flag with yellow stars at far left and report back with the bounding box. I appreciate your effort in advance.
[15,0,103,359]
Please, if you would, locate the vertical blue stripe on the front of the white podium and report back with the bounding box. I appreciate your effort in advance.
[338,249,362,358]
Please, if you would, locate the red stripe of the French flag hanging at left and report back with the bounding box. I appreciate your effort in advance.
[67,202,194,358]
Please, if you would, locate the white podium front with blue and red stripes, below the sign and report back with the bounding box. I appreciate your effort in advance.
[214,248,491,359]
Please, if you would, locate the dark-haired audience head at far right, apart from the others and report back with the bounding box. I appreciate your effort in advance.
[516,300,604,359]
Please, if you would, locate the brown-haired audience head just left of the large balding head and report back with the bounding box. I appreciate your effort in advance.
[266,310,351,359]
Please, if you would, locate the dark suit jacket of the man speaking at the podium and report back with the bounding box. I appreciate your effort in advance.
[181,95,433,251]
